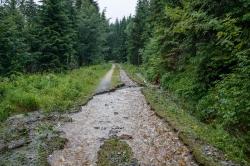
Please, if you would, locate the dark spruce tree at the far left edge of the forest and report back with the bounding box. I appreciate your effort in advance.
[0,0,30,74]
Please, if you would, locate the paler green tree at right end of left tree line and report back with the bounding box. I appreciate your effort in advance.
[77,0,106,66]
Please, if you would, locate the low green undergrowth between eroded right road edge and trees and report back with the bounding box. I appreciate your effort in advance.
[143,88,249,165]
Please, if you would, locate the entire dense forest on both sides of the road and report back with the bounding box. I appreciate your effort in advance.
[0,0,250,163]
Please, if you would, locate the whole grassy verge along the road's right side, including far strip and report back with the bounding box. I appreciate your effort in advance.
[123,64,250,166]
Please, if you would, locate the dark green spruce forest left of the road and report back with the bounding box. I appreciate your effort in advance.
[0,0,109,75]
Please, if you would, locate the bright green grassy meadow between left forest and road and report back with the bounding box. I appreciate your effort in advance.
[0,65,111,121]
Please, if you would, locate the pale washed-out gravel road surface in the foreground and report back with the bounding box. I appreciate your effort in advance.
[49,67,197,166]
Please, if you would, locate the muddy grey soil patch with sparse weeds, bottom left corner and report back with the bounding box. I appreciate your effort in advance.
[0,112,71,166]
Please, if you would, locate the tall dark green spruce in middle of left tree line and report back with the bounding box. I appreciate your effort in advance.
[38,0,75,70]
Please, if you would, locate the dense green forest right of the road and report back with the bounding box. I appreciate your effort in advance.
[111,0,250,158]
